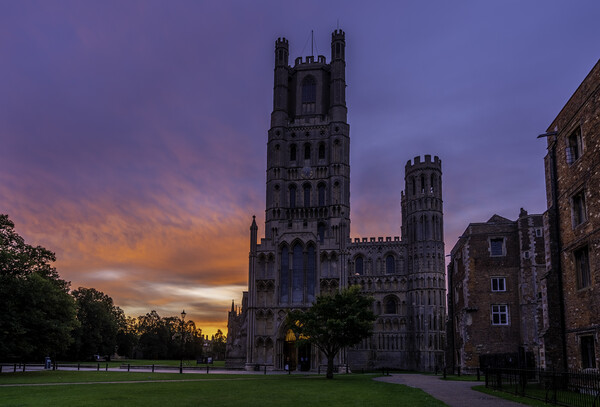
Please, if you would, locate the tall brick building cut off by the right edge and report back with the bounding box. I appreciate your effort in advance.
[543,61,600,369]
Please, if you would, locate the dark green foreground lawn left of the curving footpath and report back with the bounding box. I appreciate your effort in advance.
[0,371,445,407]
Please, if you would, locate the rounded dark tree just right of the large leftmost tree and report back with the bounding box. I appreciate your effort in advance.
[71,287,125,360]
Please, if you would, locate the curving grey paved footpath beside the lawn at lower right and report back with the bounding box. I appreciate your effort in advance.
[375,374,523,407]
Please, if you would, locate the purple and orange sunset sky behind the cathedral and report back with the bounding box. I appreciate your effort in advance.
[0,0,600,333]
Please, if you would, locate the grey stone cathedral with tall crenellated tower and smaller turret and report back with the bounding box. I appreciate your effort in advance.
[226,30,446,371]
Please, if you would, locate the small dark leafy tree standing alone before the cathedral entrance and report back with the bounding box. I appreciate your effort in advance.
[287,286,375,379]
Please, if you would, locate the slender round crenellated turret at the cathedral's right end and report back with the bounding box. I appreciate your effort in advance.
[402,155,446,369]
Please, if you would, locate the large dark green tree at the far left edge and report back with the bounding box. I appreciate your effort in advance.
[0,214,78,361]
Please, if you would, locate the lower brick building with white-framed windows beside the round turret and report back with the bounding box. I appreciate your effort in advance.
[446,209,545,371]
